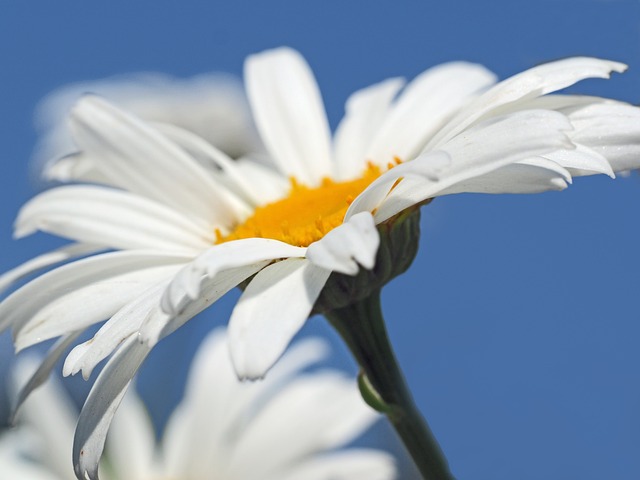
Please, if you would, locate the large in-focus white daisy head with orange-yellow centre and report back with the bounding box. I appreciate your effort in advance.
[0,48,640,476]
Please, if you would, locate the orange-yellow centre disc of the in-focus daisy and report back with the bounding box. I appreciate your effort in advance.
[216,163,394,247]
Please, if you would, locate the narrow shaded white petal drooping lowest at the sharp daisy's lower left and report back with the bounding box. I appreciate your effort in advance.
[73,337,149,480]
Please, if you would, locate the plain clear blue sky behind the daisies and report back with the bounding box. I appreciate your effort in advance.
[0,0,640,480]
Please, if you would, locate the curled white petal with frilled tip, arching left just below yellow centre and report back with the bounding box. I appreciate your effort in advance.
[161,238,306,314]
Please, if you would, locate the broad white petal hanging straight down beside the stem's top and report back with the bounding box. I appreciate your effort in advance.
[229,259,331,378]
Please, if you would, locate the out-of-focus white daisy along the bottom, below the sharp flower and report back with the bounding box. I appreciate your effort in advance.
[0,332,395,480]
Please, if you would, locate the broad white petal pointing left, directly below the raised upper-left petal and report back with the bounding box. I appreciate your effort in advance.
[15,185,214,252]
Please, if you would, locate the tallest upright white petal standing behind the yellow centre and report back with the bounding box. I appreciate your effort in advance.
[245,48,331,186]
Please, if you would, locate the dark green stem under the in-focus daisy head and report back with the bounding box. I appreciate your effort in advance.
[325,290,454,480]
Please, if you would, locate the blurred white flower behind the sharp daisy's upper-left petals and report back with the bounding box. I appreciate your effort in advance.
[34,72,263,181]
